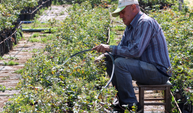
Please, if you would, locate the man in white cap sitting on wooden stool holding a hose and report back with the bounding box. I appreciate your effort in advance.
[93,0,171,111]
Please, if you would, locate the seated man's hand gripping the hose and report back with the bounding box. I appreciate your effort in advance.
[92,44,110,53]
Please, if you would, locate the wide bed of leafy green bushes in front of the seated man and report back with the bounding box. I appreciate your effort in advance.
[4,1,116,113]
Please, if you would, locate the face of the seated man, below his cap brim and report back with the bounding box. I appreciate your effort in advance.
[119,5,134,25]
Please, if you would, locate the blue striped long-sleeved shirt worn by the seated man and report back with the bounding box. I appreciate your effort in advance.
[112,12,171,76]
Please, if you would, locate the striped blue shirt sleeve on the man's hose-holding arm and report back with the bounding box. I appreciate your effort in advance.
[112,21,154,58]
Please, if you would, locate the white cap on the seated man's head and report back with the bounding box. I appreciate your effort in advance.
[112,0,139,17]
